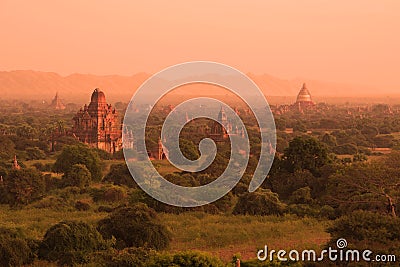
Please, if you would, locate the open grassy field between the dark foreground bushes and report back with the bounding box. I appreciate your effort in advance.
[0,205,329,261]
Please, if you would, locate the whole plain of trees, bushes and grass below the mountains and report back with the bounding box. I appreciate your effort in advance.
[0,101,400,266]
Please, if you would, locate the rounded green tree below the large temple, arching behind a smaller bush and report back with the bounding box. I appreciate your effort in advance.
[54,144,101,181]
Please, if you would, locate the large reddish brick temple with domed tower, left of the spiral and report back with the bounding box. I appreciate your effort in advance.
[72,88,122,153]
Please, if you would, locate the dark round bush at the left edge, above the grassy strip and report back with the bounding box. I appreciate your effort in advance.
[4,169,46,205]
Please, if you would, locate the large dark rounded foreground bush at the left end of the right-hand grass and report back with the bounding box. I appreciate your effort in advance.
[98,204,171,250]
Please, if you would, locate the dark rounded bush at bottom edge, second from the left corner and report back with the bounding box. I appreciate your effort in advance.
[39,221,108,265]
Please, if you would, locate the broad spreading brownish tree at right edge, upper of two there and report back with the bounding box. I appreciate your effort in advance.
[326,152,400,217]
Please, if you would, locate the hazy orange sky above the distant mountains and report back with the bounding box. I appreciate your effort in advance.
[0,0,400,92]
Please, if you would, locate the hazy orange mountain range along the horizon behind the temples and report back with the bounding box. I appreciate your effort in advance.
[0,70,384,103]
